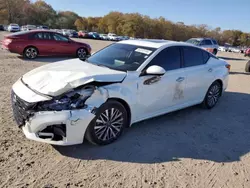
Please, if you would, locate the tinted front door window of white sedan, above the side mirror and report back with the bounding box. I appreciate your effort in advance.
[147,47,181,71]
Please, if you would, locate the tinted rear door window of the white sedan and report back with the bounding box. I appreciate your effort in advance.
[183,46,204,67]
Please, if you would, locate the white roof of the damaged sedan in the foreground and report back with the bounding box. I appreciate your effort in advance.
[118,39,194,48]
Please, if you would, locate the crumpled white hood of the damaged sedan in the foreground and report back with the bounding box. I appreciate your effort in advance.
[22,59,127,96]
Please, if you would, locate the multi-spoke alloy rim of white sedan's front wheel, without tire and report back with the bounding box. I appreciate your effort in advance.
[94,108,124,141]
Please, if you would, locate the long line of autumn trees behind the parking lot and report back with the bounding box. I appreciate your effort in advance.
[0,0,250,46]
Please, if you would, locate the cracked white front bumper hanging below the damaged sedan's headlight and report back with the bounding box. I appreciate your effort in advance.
[22,109,95,146]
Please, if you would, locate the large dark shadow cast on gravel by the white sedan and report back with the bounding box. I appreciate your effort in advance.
[54,92,250,163]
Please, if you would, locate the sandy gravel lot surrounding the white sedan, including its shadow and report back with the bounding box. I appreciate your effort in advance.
[0,32,250,188]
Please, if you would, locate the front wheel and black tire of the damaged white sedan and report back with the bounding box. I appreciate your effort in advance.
[85,100,128,145]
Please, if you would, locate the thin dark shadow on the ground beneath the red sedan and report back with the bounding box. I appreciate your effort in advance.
[18,56,75,63]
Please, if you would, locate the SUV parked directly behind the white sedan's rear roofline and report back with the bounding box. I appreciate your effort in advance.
[186,38,219,55]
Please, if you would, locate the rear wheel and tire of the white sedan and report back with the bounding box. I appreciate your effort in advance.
[202,81,222,109]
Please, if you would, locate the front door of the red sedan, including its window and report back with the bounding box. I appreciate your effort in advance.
[52,33,73,55]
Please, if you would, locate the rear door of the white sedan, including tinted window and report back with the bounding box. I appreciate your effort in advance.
[182,46,213,104]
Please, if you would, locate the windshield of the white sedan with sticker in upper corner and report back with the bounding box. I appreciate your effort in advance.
[87,43,156,72]
